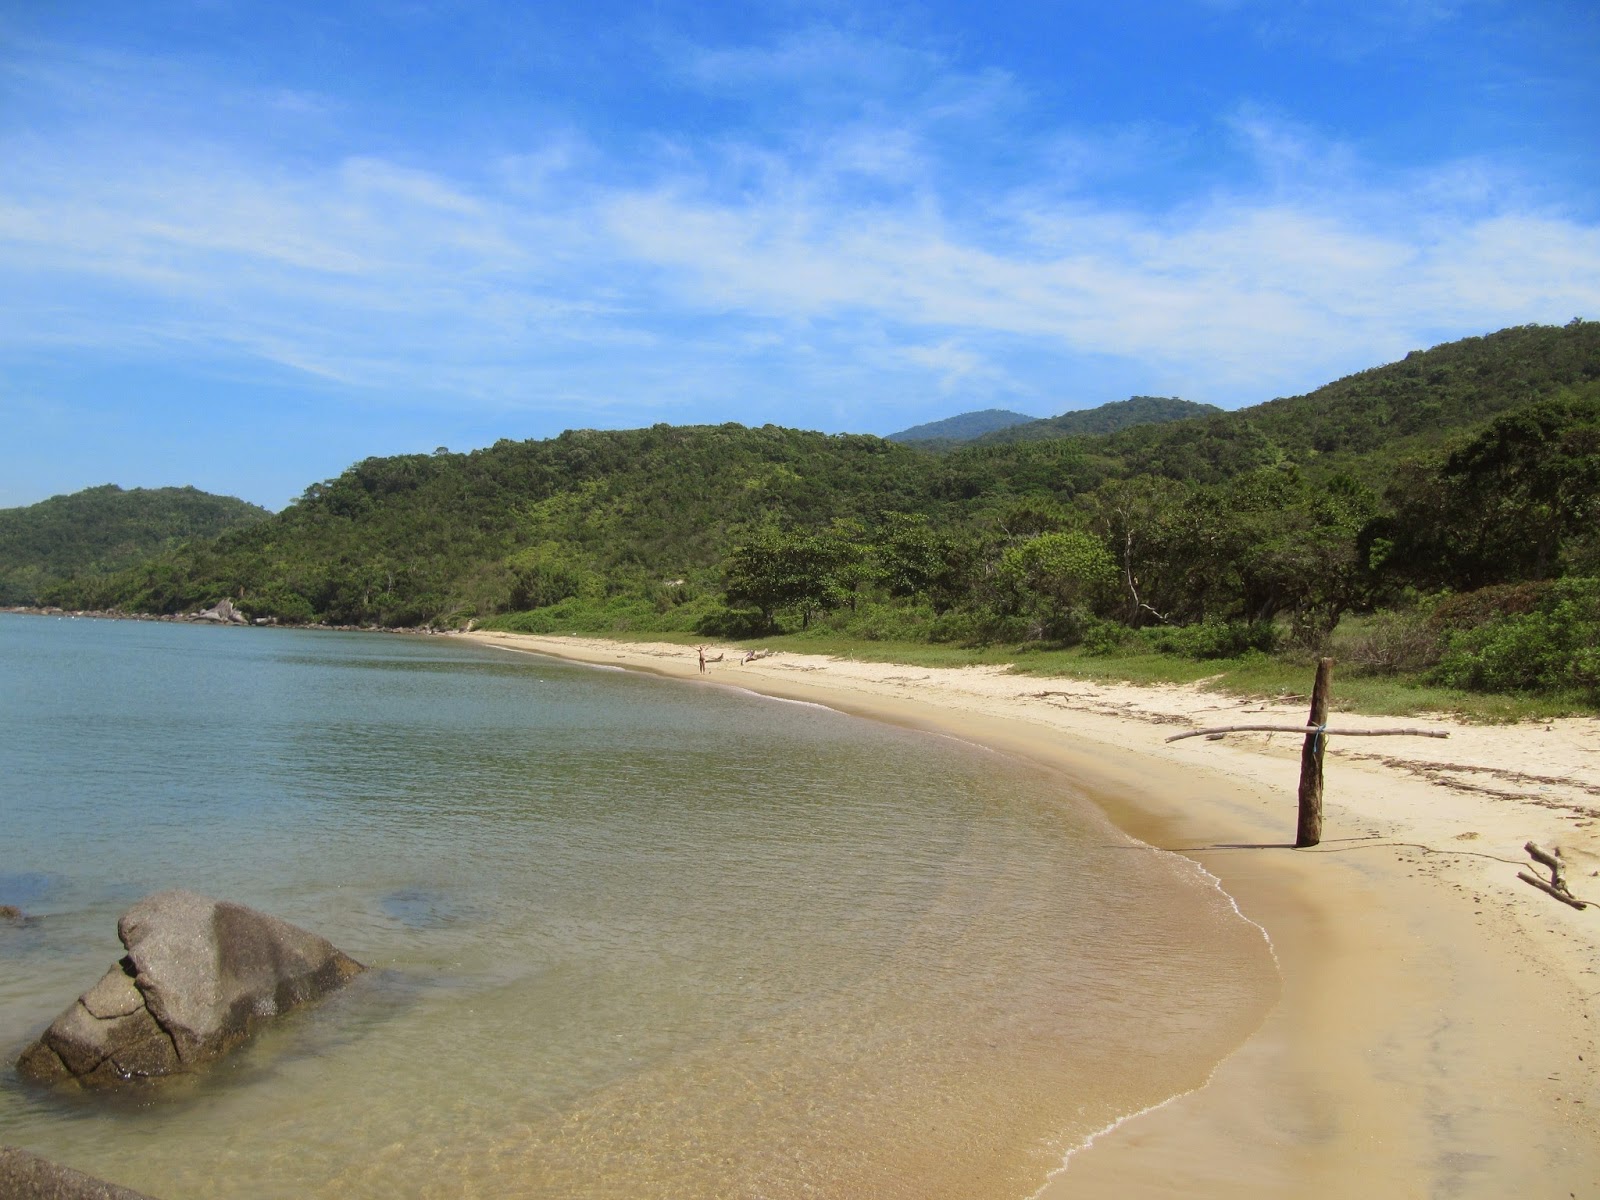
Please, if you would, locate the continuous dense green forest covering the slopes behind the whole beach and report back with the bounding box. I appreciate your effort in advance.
[34,322,1600,702]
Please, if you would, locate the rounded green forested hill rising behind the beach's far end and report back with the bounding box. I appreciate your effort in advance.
[62,424,930,624]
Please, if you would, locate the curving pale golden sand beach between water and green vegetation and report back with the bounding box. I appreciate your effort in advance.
[464,634,1600,1200]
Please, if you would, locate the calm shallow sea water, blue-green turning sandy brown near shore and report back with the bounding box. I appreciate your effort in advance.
[0,614,1275,1200]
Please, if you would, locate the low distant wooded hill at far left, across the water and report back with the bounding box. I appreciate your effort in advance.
[0,483,272,605]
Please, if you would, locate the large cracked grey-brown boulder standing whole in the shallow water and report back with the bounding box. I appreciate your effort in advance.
[16,891,365,1086]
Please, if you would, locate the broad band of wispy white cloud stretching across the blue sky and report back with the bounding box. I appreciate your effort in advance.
[0,20,1600,438]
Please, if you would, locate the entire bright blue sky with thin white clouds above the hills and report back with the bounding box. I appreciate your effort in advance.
[0,0,1600,509]
